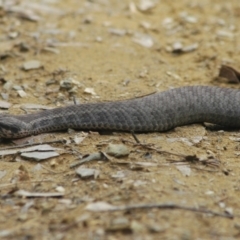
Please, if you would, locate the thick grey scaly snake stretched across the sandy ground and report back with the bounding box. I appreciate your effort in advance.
[0,86,240,139]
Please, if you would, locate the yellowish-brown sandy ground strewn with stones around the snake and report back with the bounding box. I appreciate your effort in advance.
[0,0,240,240]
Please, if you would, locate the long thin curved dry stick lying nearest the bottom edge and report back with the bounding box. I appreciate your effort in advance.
[94,203,234,219]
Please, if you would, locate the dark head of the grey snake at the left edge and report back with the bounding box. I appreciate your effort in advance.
[0,114,28,138]
